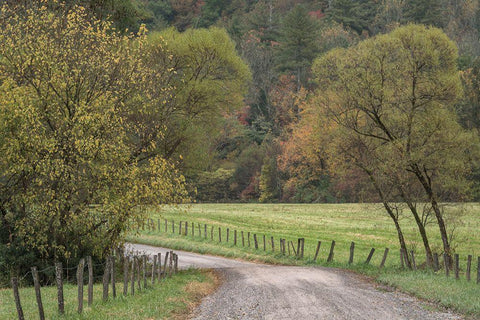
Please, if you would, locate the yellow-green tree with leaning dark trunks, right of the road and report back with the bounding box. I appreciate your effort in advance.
[315,25,476,264]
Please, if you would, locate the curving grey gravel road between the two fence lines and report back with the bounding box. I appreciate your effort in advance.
[129,244,463,320]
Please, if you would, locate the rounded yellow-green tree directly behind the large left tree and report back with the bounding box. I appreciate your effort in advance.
[143,27,251,171]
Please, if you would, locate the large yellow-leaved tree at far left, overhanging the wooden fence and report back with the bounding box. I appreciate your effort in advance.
[0,1,186,278]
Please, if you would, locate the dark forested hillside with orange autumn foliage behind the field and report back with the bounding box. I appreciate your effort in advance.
[117,0,480,202]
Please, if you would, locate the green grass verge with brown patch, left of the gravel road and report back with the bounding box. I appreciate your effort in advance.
[0,269,216,320]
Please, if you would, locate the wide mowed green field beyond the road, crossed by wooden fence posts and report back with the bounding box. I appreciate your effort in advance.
[129,204,480,318]
